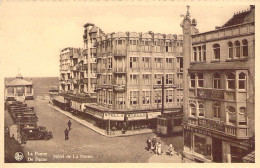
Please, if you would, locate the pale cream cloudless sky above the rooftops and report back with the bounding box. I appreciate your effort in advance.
[0,0,253,77]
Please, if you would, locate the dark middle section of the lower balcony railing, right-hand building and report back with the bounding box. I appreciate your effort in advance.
[198,118,225,131]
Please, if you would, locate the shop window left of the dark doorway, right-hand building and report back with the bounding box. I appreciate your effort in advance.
[194,135,211,156]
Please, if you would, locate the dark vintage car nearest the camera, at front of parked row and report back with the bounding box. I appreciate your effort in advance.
[21,126,53,140]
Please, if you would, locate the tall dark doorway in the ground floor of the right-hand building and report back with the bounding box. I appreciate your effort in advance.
[212,138,222,163]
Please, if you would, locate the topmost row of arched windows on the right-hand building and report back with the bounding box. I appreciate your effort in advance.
[192,39,249,62]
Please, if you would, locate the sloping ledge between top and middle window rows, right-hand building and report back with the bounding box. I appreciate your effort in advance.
[188,61,249,71]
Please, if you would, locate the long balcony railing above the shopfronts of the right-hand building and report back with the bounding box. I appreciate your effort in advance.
[188,117,248,139]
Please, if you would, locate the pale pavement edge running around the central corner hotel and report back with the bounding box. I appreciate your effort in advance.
[48,104,154,138]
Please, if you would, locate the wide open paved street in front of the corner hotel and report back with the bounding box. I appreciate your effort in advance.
[6,100,185,163]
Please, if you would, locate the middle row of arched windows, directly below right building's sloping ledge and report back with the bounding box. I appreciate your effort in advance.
[190,72,247,89]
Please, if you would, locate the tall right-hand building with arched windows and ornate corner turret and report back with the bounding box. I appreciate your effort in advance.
[181,6,255,163]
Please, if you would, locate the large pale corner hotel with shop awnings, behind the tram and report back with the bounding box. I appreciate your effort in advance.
[84,24,183,134]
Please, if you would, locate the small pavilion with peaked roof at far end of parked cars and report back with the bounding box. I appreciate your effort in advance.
[5,73,34,101]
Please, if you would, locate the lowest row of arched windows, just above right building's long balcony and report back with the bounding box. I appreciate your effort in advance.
[190,101,247,125]
